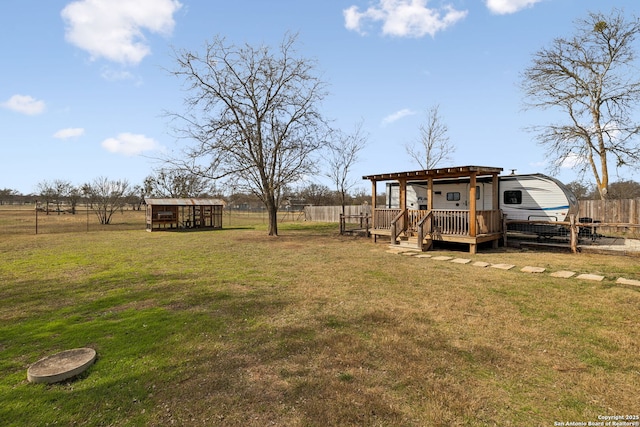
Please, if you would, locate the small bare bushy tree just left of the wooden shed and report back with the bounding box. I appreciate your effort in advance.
[82,177,129,225]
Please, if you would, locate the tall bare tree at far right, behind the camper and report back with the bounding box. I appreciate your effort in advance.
[522,9,640,199]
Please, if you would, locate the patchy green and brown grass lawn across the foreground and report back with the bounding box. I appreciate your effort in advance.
[0,217,640,426]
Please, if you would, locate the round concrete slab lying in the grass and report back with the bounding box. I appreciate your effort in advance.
[27,348,96,384]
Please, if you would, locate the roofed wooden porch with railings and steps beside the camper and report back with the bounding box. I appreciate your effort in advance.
[362,166,503,253]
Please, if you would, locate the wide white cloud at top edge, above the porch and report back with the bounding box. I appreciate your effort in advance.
[343,0,467,37]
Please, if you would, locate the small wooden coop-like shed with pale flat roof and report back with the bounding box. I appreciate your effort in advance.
[145,198,225,231]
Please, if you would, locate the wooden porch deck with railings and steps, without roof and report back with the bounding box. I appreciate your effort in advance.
[370,209,503,253]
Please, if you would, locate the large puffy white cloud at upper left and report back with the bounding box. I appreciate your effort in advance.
[61,0,182,64]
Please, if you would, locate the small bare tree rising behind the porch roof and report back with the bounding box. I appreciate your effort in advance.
[405,105,456,169]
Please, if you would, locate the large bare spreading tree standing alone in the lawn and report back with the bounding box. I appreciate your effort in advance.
[171,36,326,235]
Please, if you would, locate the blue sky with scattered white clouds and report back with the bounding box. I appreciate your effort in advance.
[0,0,640,194]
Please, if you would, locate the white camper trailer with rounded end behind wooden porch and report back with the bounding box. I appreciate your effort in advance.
[386,174,578,222]
